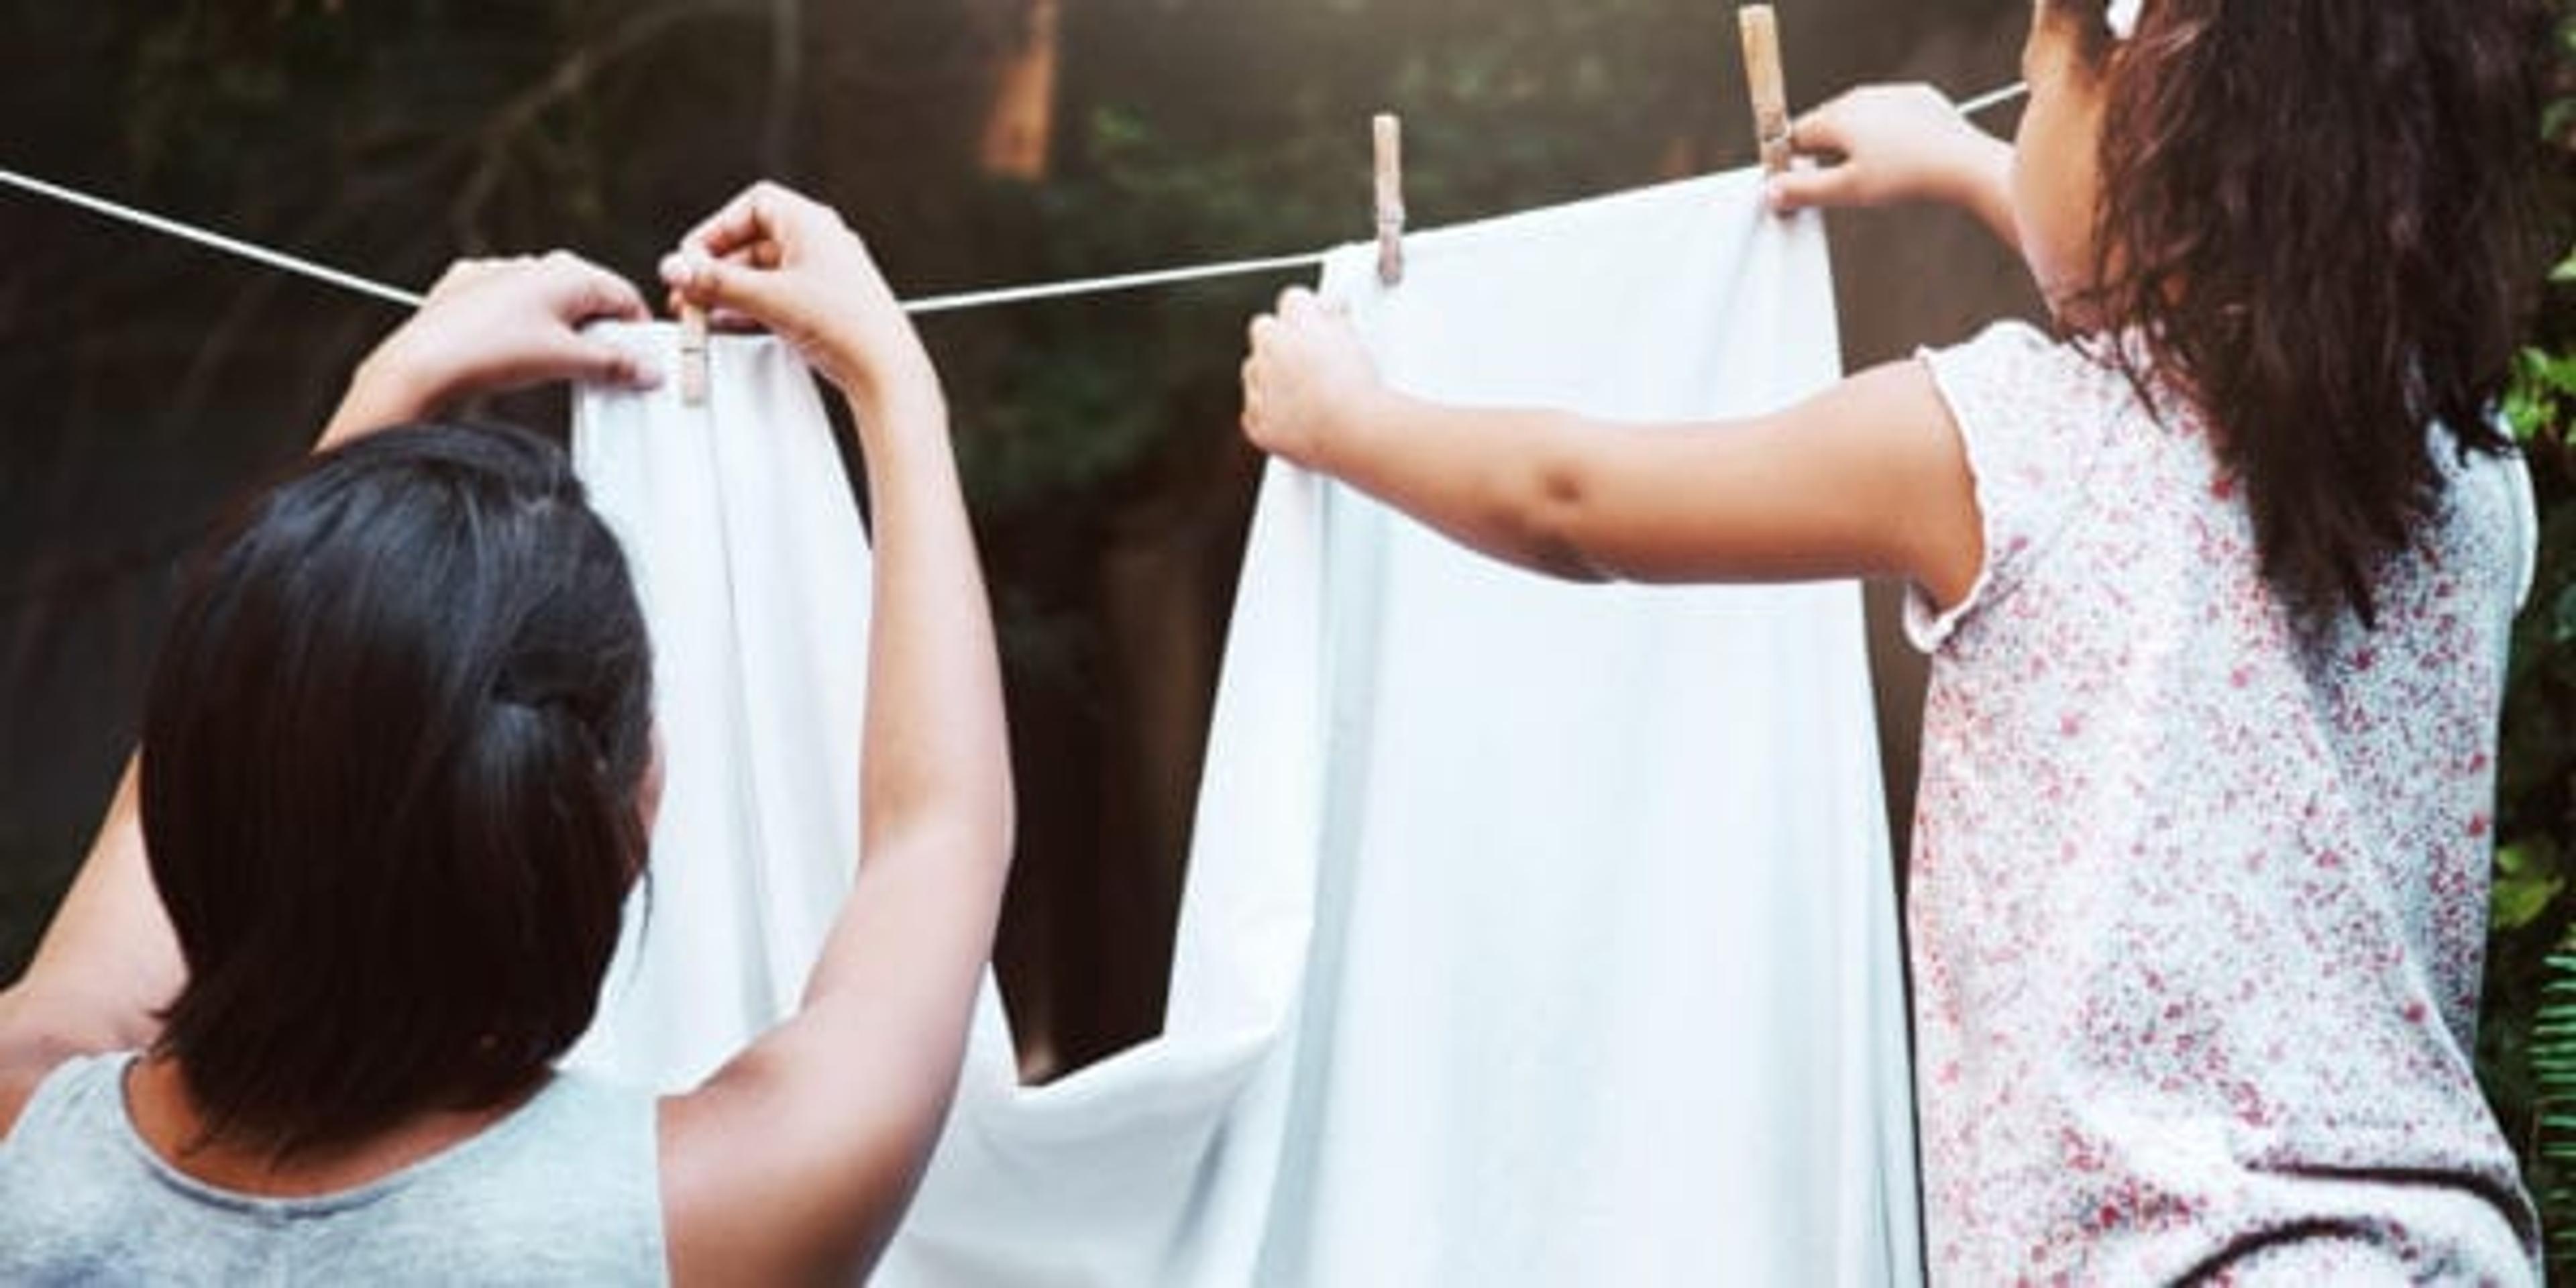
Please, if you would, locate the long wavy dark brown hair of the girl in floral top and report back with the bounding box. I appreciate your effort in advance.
[2048,0,2551,623]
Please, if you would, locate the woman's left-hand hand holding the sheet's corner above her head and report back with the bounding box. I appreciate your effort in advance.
[322,250,662,448]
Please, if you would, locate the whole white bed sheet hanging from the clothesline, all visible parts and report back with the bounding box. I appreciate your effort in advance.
[577,172,1922,1288]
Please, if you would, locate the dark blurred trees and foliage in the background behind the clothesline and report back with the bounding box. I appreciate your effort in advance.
[0,0,2576,1226]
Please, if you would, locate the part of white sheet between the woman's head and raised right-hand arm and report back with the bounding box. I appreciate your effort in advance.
[567,325,871,1089]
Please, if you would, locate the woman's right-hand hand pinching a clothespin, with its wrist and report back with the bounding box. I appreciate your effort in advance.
[662,183,938,412]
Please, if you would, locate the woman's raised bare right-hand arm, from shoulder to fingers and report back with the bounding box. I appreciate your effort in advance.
[662,185,1012,1283]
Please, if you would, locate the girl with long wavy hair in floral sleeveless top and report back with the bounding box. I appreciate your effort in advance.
[1244,0,2542,1285]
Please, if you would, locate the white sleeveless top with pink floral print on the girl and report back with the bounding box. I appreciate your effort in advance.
[1909,325,2537,1285]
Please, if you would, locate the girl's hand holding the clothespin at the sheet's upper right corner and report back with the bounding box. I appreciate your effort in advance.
[1770,85,2012,221]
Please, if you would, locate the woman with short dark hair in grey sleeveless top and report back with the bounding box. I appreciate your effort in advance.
[0,185,1010,1283]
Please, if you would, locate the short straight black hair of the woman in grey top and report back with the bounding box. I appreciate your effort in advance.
[142,425,654,1154]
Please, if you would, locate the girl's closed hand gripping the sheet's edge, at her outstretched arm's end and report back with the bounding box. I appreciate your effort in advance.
[1244,286,1383,466]
